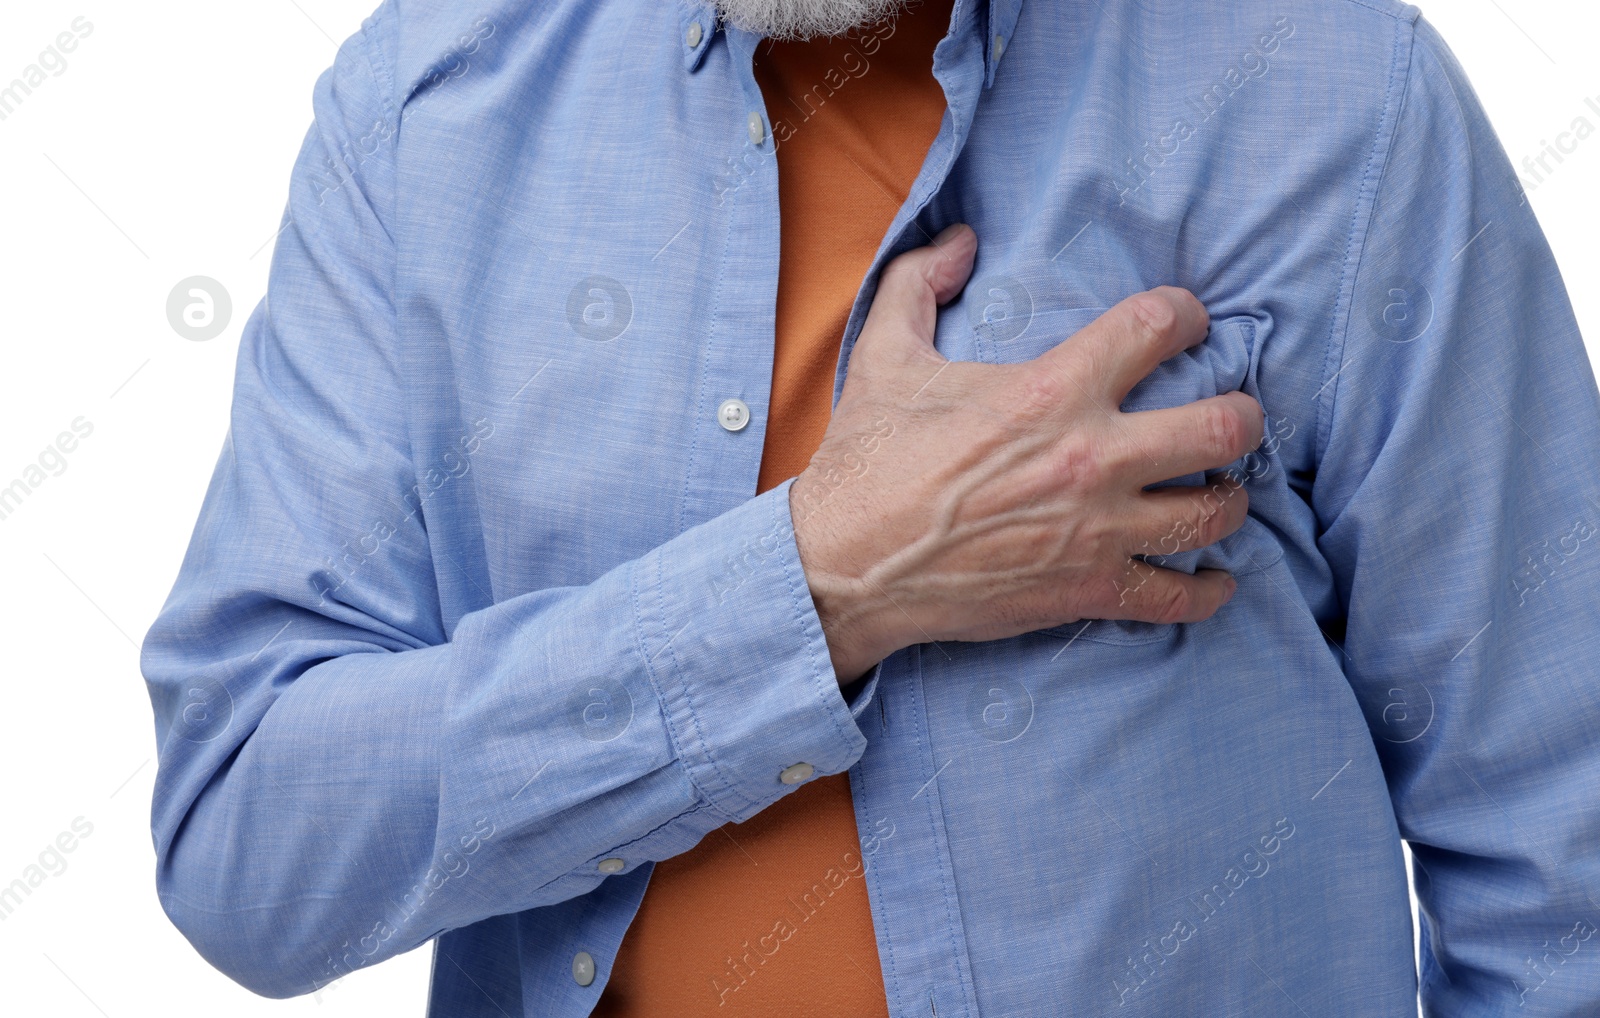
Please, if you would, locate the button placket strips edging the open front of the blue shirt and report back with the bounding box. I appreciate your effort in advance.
[550,0,1017,1018]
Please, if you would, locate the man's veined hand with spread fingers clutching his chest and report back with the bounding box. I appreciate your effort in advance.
[789,226,1262,683]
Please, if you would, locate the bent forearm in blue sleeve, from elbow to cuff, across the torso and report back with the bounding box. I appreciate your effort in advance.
[146,480,866,996]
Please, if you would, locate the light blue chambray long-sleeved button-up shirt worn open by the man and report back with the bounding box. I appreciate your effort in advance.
[142,0,1600,1018]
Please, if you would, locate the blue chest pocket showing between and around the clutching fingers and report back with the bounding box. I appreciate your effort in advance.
[957,297,1283,645]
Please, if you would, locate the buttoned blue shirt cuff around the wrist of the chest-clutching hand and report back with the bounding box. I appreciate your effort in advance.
[632,480,877,821]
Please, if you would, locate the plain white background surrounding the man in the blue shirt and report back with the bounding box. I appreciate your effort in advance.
[0,0,1600,1018]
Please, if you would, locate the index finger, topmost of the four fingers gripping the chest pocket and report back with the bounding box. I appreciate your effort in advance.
[1035,287,1210,410]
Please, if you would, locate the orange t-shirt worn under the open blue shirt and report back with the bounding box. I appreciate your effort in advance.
[594,0,952,1018]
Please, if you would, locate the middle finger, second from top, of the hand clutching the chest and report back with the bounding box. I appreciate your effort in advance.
[1112,392,1264,487]
